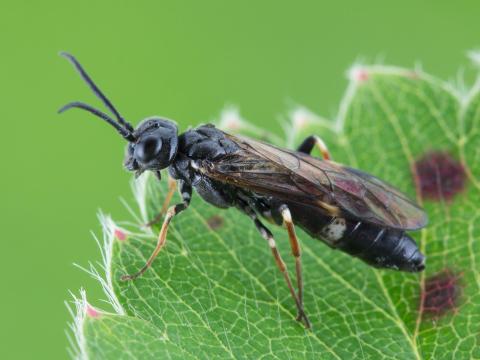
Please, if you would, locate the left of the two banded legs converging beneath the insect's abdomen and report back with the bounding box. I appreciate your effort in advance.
[243,205,310,329]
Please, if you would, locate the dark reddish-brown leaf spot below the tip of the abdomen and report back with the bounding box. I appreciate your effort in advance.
[420,269,462,318]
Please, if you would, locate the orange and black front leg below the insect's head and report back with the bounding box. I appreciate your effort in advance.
[121,181,192,281]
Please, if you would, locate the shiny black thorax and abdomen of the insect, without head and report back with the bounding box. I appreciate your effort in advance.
[169,125,424,271]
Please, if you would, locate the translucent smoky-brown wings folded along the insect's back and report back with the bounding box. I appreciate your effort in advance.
[208,134,427,230]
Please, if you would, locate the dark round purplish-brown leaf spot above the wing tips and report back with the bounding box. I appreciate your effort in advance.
[415,151,467,201]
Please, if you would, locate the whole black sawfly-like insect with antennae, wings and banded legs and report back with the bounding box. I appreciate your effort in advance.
[60,53,427,327]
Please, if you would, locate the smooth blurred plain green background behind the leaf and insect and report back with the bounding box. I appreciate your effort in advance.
[0,0,480,359]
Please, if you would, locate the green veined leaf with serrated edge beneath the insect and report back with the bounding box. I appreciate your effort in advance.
[69,66,480,359]
